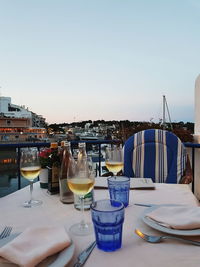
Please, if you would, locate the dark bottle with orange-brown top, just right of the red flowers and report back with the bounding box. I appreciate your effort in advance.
[48,142,60,194]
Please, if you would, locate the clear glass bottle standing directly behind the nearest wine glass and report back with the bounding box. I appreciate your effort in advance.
[74,143,94,210]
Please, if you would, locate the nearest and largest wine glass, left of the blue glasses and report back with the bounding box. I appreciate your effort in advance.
[67,158,94,236]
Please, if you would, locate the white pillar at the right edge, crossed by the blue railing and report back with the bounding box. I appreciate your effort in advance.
[194,75,200,199]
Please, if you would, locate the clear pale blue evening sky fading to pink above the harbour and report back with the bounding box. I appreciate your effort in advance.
[0,0,200,123]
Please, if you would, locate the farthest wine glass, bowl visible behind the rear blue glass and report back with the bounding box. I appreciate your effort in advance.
[105,145,124,176]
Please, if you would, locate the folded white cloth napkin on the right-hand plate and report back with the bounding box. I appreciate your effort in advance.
[146,206,200,230]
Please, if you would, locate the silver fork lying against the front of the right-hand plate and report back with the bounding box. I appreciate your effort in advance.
[135,229,200,246]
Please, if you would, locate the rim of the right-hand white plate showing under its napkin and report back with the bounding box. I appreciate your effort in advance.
[142,205,200,236]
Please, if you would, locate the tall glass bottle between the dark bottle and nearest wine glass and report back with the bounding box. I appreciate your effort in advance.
[59,141,74,204]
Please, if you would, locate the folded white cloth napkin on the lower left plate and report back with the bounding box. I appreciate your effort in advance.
[0,226,71,267]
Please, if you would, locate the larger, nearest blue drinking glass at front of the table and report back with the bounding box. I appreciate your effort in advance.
[91,199,124,251]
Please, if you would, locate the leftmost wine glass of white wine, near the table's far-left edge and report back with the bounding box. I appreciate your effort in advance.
[20,147,42,208]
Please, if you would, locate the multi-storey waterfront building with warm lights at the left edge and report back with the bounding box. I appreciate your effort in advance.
[0,97,47,141]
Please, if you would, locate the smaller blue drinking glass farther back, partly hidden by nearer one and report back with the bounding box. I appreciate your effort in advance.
[107,176,130,207]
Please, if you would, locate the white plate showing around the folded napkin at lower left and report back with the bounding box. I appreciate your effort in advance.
[0,234,75,267]
